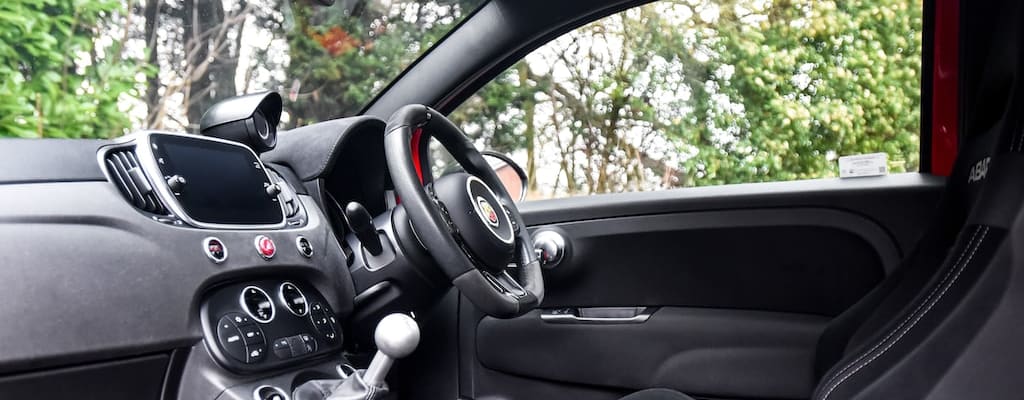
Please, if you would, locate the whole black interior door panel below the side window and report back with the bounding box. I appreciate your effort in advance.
[458,174,944,400]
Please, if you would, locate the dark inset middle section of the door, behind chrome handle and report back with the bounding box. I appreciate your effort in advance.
[540,208,899,315]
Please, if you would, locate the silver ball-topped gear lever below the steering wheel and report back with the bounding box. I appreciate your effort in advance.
[317,314,420,400]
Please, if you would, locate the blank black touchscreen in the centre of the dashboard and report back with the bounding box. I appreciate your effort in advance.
[151,134,285,225]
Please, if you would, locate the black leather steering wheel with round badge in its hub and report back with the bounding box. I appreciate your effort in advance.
[384,104,544,318]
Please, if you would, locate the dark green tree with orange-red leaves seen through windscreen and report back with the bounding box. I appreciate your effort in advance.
[280,0,478,126]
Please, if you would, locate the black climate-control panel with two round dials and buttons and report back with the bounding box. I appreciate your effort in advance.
[201,279,342,372]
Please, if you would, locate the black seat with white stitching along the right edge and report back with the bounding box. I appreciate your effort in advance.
[623,16,1024,400]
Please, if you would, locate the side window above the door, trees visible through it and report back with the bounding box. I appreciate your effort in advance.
[451,0,922,198]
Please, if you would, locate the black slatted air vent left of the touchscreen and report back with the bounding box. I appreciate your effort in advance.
[103,147,168,215]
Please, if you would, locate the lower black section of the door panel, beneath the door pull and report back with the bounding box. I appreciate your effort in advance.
[477,307,828,398]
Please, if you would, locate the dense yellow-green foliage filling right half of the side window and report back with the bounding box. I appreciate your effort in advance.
[680,0,922,184]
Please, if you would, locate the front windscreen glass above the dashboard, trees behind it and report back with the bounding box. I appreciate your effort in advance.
[0,0,484,138]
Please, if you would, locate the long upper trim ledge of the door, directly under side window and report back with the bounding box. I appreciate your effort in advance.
[519,173,945,256]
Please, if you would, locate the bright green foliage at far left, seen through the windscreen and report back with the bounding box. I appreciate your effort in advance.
[0,0,145,138]
